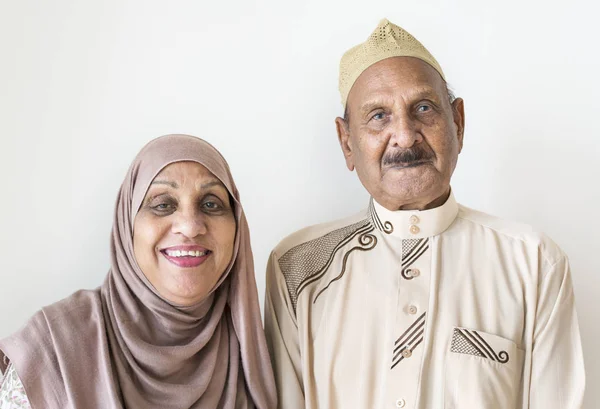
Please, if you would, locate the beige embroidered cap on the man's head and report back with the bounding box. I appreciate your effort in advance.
[339,19,446,107]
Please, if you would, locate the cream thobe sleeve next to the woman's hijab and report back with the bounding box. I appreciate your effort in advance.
[265,252,305,409]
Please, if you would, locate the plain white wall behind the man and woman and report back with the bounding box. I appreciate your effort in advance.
[0,0,600,409]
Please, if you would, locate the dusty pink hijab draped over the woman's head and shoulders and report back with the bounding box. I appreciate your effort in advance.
[0,135,277,409]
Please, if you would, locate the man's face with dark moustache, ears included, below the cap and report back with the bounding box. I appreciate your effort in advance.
[336,57,464,210]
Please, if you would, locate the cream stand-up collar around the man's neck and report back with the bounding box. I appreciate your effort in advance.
[369,192,458,239]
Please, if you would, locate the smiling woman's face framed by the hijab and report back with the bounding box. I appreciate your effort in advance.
[133,162,236,306]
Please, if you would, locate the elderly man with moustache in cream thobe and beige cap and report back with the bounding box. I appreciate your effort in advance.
[265,20,585,409]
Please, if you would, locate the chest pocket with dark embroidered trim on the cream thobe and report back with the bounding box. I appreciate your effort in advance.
[444,327,524,409]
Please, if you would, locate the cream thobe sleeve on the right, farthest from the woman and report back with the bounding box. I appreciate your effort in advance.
[529,256,585,409]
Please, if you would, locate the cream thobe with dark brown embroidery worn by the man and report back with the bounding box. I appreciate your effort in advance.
[265,195,585,409]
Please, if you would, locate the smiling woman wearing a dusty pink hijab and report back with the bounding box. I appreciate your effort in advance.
[0,135,276,409]
